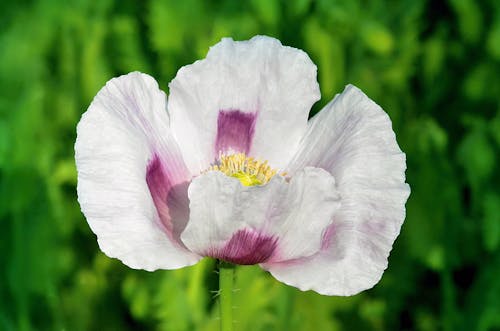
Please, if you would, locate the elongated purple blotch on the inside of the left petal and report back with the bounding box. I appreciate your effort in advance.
[146,154,189,245]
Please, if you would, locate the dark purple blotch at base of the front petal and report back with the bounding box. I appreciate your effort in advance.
[206,229,278,265]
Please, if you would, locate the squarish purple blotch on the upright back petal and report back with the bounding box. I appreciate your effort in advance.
[215,109,257,155]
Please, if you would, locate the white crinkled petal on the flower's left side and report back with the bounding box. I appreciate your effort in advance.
[75,72,200,270]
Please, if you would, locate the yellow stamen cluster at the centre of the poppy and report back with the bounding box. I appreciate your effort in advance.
[208,153,286,186]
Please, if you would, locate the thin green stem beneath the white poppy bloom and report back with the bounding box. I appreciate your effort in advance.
[219,261,235,331]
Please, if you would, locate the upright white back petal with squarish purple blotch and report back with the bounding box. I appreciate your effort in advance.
[168,36,320,173]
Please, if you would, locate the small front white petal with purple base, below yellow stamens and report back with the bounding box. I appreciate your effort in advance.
[181,167,340,264]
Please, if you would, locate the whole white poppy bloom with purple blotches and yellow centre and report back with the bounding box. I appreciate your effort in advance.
[75,36,410,295]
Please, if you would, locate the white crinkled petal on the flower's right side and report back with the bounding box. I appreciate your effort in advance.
[263,86,410,295]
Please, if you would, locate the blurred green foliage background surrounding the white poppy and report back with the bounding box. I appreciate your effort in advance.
[0,0,500,331]
